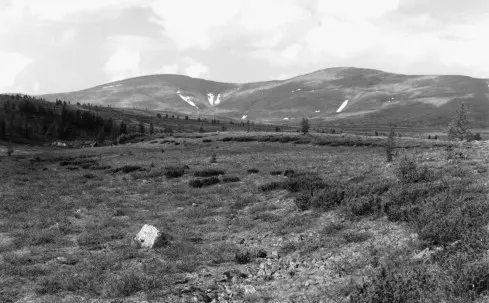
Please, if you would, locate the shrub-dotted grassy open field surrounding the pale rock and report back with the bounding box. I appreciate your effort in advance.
[0,132,489,302]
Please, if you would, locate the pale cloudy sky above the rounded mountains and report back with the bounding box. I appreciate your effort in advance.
[0,0,489,94]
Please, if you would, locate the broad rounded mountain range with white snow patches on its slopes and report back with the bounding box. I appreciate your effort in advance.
[42,67,489,128]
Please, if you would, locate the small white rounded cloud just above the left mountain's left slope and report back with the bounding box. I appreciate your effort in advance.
[104,48,141,81]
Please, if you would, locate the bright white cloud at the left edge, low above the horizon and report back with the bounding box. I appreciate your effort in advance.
[0,51,31,91]
